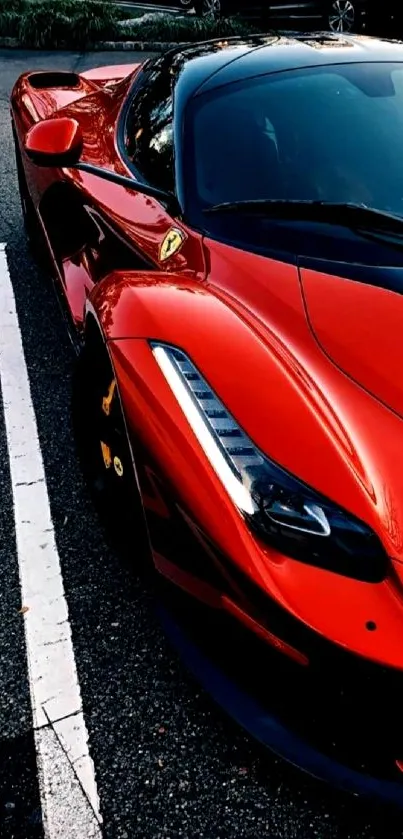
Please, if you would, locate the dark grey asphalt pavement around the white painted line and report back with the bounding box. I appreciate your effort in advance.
[0,51,403,839]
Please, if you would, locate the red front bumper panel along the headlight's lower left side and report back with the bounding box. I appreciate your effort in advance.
[105,338,403,668]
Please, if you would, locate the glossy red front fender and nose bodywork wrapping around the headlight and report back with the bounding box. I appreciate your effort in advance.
[88,272,403,666]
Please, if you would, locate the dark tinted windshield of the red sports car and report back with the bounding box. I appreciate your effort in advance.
[188,63,403,235]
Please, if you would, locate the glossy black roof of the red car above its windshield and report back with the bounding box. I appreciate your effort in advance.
[171,32,403,100]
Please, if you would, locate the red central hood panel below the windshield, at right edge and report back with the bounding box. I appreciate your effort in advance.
[300,267,403,424]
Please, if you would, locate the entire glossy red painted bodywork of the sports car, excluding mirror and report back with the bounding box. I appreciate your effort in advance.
[12,55,403,684]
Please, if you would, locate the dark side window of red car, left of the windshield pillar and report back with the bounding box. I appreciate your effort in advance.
[125,58,174,190]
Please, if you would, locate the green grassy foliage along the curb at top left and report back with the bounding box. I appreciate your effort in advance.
[0,0,254,49]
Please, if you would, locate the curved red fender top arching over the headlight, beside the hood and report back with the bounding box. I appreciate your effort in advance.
[87,271,403,559]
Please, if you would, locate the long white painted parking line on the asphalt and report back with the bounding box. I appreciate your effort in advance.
[0,244,102,839]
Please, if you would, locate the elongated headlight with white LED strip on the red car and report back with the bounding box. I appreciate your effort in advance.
[151,342,387,582]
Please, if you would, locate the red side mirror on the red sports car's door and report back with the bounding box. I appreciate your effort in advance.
[24,117,83,168]
